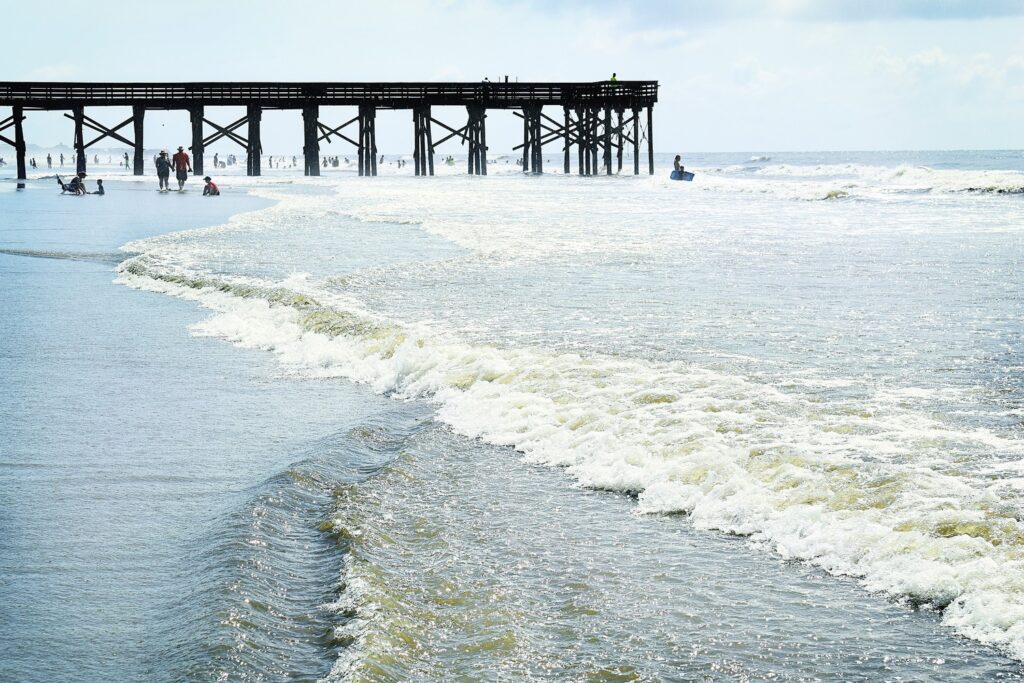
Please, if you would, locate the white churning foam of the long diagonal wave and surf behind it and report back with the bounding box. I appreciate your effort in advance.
[119,162,1024,671]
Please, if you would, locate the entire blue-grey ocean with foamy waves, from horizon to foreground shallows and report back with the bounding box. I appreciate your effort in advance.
[0,151,1024,681]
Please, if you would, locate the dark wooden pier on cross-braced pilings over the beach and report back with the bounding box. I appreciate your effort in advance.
[0,81,657,178]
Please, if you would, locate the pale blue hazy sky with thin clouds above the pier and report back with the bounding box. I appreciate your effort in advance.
[0,0,1024,156]
